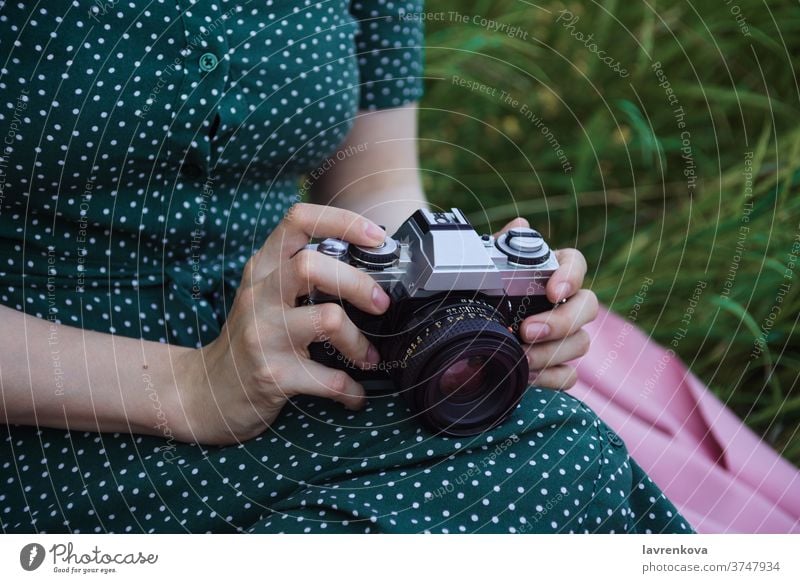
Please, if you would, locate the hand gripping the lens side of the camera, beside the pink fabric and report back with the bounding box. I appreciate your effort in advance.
[498,218,598,390]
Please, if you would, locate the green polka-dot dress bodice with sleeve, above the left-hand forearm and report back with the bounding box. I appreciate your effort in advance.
[0,0,422,346]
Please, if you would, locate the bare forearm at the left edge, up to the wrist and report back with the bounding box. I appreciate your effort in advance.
[0,306,189,438]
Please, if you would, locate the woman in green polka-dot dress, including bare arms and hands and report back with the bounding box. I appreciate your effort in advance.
[0,0,689,532]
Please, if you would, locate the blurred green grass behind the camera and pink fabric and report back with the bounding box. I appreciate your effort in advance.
[420,0,800,465]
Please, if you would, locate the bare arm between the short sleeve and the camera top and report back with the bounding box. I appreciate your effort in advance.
[311,104,427,233]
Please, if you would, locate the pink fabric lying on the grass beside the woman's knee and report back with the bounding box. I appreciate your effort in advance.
[570,309,800,533]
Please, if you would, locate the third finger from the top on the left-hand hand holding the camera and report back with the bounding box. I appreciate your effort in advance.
[284,303,380,368]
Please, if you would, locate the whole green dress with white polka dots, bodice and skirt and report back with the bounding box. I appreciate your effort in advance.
[0,0,691,533]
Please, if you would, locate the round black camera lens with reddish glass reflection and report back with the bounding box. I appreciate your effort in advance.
[390,298,528,435]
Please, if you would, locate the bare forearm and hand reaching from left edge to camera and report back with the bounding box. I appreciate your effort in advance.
[0,204,389,444]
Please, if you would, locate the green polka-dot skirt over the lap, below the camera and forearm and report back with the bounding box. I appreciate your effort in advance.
[0,388,689,532]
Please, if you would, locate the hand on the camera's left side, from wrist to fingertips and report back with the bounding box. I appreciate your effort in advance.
[173,203,389,445]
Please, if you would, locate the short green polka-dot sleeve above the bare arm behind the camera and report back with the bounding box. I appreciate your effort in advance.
[350,0,424,109]
